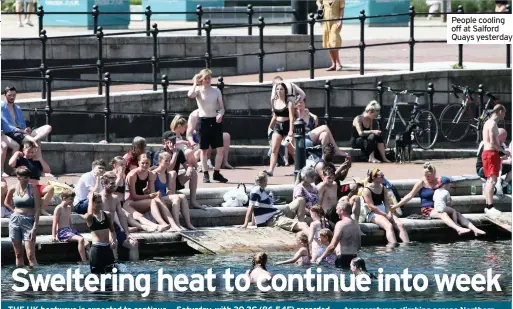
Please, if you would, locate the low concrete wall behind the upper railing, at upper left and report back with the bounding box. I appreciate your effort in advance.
[2,35,330,91]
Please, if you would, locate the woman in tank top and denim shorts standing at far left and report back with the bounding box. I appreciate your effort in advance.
[5,166,41,266]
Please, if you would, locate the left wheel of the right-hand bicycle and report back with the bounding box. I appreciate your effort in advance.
[440,103,470,143]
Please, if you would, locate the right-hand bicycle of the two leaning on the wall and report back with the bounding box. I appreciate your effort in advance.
[440,85,498,143]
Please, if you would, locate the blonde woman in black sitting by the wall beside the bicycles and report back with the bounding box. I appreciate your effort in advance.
[351,101,390,163]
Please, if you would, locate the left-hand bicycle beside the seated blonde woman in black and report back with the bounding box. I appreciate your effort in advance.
[385,87,438,150]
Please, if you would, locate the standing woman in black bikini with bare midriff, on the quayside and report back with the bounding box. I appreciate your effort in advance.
[265,83,294,176]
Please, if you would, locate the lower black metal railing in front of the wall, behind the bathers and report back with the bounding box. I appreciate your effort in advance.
[6,70,511,142]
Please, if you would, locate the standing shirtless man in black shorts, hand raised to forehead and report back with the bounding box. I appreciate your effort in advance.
[187,69,228,183]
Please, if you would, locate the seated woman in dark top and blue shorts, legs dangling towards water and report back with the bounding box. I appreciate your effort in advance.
[362,168,410,247]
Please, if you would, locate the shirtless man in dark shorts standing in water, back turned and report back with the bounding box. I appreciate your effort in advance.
[316,199,362,268]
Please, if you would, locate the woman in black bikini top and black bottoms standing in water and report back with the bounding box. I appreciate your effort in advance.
[85,192,117,274]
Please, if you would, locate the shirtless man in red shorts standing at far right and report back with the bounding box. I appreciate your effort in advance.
[481,104,506,215]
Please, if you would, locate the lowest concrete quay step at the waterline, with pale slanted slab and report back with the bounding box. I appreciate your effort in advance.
[0,213,511,265]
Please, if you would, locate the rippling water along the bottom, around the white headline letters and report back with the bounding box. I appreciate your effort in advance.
[1,240,512,301]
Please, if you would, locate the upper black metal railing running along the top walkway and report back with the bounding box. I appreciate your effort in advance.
[2,5,511,99]
